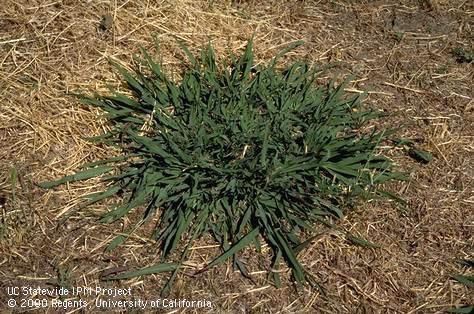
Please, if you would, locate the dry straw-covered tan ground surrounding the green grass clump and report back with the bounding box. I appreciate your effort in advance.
[0,0,474,313]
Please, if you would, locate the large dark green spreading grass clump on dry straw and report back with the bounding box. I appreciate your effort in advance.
[40,41,403,291]
